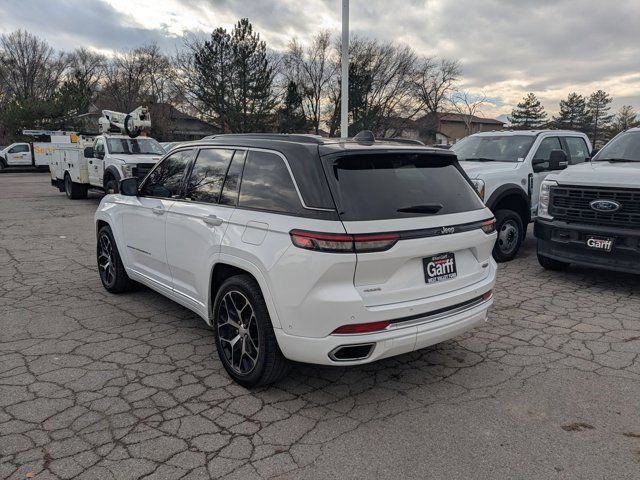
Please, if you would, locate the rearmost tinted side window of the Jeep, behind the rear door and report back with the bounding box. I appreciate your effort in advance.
[238,151,302,213]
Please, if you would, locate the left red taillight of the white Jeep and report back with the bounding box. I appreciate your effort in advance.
[289,230,400,253]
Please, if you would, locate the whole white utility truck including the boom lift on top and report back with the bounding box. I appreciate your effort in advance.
[49,107,164,199]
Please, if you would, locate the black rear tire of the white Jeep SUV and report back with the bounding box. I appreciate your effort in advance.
[213,275,291,388]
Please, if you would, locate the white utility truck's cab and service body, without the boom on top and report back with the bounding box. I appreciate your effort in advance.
[49,134,165,199]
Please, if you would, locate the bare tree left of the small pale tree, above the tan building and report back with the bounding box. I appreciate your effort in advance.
[414,57,462,115]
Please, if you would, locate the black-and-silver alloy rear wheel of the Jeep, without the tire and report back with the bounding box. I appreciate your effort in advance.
[218,290,260,375]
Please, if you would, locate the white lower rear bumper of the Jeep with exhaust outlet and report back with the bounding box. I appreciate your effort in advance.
[275,285,493,365]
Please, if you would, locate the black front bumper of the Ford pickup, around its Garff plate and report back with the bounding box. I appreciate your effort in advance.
[534,219,640,274]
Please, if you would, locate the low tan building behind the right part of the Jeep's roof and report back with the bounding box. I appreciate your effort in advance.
[385,113,505,145]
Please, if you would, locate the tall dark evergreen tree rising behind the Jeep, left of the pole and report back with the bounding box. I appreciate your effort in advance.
[194,18,276,133]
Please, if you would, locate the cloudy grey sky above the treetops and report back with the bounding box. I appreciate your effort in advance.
[0,0,640,116]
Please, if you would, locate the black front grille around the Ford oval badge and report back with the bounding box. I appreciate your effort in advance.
[549,186,640,228]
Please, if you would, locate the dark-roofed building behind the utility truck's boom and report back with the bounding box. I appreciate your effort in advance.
[77,103,222,142]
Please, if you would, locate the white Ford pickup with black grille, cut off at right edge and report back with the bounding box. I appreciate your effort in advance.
[534,128,640,274]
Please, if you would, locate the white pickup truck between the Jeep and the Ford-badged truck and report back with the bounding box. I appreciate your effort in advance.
[451,130,591,262]
